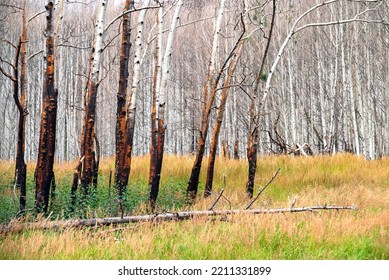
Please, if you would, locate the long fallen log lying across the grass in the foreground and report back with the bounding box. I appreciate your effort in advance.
[0,205,358,233]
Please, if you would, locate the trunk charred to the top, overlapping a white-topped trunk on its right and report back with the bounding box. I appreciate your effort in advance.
[115,0,134,200]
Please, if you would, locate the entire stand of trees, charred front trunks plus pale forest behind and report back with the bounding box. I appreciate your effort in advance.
[0,0,389,211]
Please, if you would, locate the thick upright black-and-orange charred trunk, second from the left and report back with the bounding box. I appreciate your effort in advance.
[35,1,58,212]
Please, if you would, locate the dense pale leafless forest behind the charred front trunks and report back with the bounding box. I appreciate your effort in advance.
[0,0,389,162]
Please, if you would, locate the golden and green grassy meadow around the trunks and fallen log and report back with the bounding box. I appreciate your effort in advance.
[0,154,389,260]
